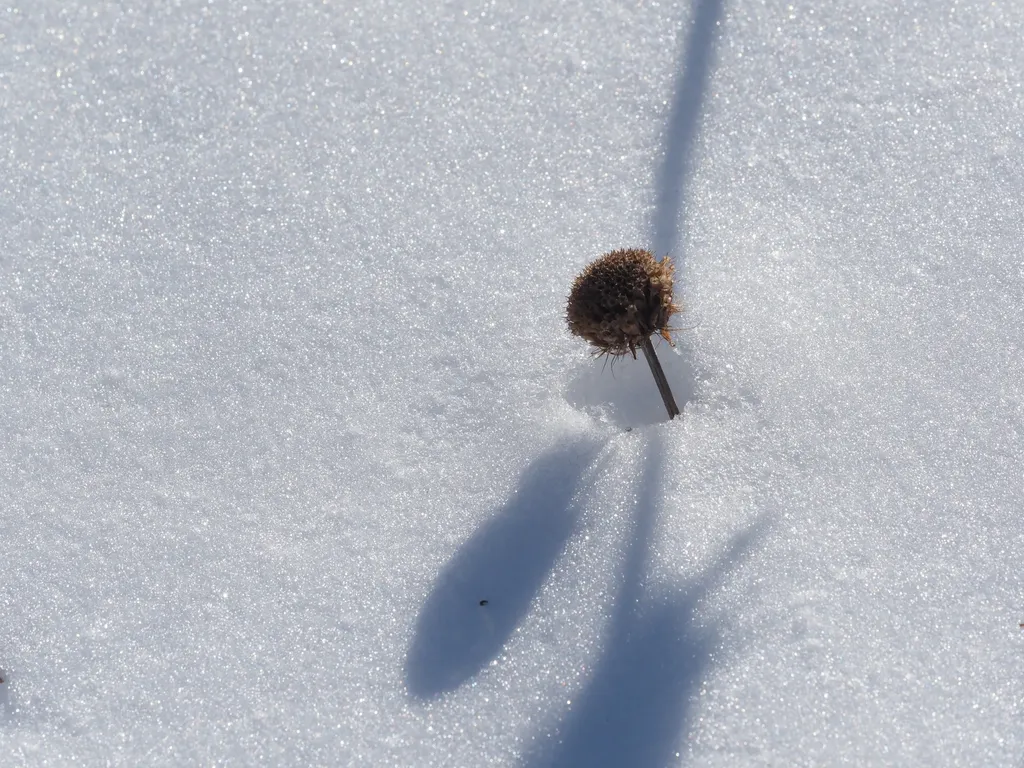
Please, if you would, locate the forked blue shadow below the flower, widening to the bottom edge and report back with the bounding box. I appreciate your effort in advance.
[526,435,762,768]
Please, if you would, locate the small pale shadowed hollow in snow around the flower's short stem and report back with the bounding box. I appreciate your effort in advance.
[565,343,696,427]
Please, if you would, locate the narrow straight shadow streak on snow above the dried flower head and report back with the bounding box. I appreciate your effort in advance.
[651,0,725,260]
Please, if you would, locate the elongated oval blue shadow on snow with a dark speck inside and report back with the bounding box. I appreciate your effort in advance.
[406,443,600,698]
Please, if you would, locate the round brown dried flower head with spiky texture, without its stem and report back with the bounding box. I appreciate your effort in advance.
[565,248,679,358]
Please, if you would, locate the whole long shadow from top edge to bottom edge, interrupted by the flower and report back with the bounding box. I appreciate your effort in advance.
[526,0,733,753]
